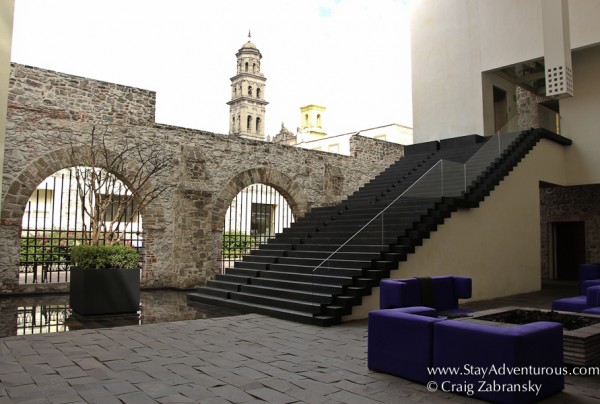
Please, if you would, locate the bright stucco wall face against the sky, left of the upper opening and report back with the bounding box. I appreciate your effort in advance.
[411,0,484,143]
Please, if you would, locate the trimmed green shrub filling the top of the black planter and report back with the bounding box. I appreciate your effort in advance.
[70,244,138,269]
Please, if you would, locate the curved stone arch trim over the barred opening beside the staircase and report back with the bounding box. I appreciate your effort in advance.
[211,167,309,231]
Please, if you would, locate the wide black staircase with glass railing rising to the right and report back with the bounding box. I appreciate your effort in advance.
[188,129,556,326]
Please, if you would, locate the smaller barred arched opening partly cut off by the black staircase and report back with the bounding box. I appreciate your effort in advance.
[221,183,296,270]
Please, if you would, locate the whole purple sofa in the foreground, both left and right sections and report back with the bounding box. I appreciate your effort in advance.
[367,306,564,403]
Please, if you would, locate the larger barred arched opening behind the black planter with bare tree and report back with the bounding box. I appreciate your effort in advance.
[19,167,144,284]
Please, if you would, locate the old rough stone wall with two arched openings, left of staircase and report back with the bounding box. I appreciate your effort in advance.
[0,65,403,293]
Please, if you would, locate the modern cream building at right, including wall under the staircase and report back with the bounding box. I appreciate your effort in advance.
[402,0,600,298]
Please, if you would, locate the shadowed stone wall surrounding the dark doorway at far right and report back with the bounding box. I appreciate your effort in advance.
[540,185,600,279]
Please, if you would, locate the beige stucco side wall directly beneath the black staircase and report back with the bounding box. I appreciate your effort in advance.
[348,140,565,319]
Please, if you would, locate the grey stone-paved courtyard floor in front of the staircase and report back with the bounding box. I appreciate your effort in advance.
[0,283,600,404]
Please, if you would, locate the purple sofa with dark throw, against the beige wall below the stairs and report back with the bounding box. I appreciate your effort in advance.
[379,276,473,316]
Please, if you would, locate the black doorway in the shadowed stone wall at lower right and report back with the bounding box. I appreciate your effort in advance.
[554,222,585,280]
